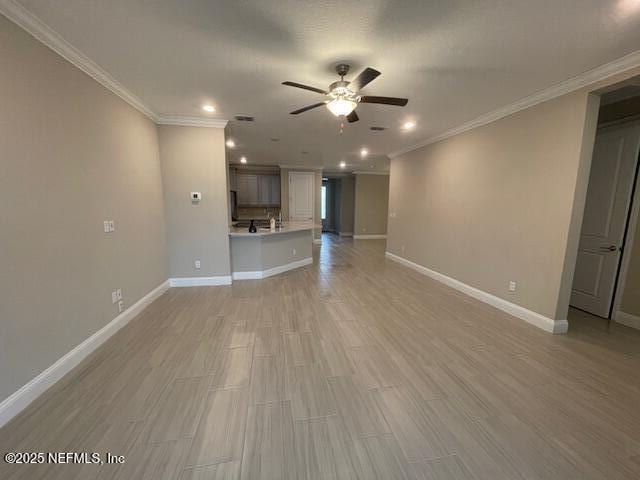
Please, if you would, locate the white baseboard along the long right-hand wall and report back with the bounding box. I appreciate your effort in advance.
[385,252,569,333]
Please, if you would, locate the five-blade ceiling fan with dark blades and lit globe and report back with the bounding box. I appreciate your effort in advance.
[282,63,409,123]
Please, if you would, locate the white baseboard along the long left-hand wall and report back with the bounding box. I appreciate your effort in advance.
[0,281,169,427]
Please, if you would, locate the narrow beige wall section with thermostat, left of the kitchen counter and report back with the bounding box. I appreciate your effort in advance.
[158,125,230,277]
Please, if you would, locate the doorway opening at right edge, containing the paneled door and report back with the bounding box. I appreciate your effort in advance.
[570,79,640,328]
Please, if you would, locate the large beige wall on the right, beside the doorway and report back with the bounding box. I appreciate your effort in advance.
[387,91,598,319]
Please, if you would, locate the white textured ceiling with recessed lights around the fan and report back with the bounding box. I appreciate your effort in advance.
[10,0,640,170]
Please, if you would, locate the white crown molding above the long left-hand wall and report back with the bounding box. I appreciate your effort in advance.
[0,0,157,121]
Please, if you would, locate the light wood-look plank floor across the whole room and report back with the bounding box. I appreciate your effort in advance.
[0,237,640,480]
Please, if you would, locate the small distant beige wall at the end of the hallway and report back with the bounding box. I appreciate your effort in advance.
[353,174,389,235]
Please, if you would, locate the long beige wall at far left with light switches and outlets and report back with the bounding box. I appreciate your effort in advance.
[0,15,167,400]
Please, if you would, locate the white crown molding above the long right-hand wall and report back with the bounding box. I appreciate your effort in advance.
[388,50,640,158]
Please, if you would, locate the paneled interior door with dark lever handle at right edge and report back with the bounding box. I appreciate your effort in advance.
[571,124,640,317]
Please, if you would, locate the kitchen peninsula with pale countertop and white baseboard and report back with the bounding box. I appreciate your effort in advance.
[229,222,313,280]
